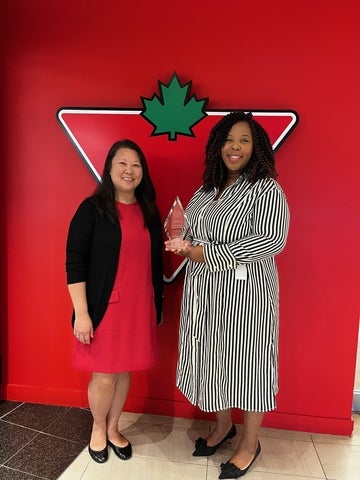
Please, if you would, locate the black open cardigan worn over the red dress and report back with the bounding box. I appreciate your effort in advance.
[65,198,163,330]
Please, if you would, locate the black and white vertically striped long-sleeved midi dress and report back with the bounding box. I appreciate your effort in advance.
[176,177,289,412]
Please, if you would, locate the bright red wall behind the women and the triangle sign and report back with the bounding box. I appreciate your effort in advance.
[0,0,360,435]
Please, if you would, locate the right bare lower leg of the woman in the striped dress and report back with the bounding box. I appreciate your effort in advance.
[229,412,264,470]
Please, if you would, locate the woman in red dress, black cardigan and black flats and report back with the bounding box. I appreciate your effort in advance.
[66,139,163,463]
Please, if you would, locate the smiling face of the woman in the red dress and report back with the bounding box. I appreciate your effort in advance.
[109,148,143,203]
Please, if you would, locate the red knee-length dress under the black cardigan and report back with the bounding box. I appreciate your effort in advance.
[73,202,156,373]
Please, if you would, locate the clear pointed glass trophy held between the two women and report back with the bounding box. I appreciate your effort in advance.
[164,196,190,253]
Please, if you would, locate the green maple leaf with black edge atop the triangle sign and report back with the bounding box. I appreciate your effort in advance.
[140,73,208,140]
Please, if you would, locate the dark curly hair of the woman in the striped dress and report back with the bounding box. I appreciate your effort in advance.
[203,110,277,192]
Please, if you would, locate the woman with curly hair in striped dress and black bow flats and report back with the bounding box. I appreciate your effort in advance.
[165,112,289,478]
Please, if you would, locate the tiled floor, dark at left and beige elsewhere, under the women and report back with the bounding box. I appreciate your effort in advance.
[0,401,360,480]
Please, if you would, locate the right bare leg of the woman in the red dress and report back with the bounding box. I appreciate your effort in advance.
[107,372,131,447]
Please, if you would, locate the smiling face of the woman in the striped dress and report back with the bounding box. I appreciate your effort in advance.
[221,122,253,176]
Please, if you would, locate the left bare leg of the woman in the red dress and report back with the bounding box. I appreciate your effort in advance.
[88,373,117,450]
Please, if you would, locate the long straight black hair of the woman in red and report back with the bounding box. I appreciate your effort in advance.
[92,138,159,227]
